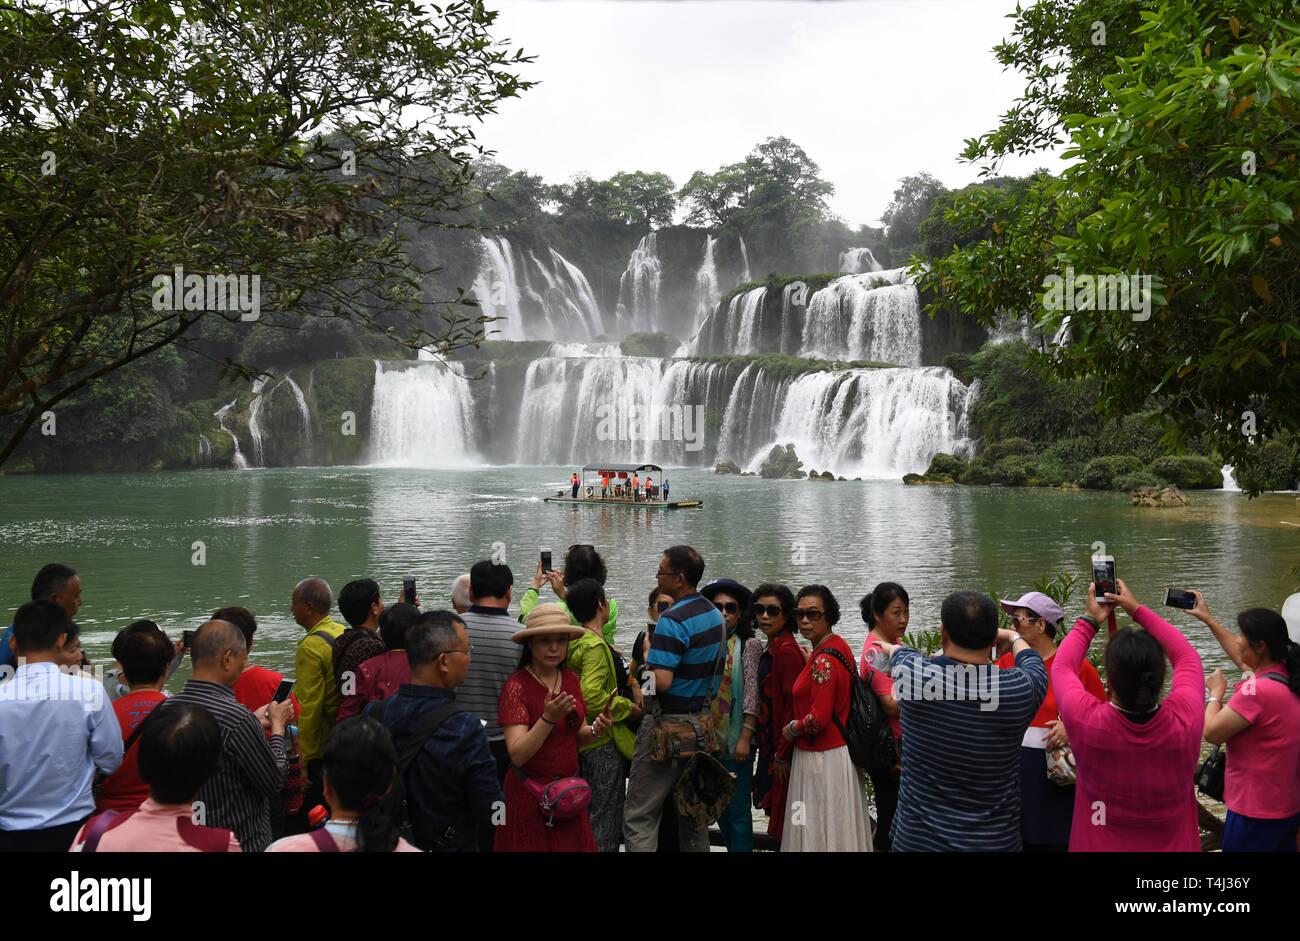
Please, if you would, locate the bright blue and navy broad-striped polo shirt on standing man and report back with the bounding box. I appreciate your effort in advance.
[646,593,727,715]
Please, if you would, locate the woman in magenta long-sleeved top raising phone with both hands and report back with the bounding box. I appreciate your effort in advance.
[1052,581,1205,853]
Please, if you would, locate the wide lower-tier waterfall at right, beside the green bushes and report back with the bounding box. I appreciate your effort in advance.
[748,367,978,478]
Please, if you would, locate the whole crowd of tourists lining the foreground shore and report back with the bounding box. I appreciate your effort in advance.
[0,545,1300,853]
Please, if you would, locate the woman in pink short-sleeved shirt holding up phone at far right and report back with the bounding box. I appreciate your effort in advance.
[1191,591,1300,853]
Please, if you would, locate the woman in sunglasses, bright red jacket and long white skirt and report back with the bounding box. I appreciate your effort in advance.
[781,585,871,853]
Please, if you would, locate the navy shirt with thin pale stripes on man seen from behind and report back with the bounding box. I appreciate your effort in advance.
[891,647,1048,853]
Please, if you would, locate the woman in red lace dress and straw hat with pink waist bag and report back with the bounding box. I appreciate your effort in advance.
[494,604,611,853]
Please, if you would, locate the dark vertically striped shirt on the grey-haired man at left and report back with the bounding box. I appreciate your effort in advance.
[166,680,289,853]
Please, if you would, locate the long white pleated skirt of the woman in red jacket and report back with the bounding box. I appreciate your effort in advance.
[781,745,872,853]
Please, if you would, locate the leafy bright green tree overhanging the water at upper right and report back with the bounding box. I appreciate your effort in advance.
[926,0,1300,496]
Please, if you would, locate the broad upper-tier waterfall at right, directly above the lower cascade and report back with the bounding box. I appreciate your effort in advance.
[800,268,920,367]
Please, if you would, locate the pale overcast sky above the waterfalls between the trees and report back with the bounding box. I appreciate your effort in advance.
[477,0,1060,226]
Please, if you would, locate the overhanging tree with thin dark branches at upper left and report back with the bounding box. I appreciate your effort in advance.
[0,0,530,463]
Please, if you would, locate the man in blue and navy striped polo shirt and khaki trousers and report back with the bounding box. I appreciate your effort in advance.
[623,546,725,853]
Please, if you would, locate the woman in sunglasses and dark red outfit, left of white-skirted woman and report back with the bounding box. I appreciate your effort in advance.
[750,584,803,840]
